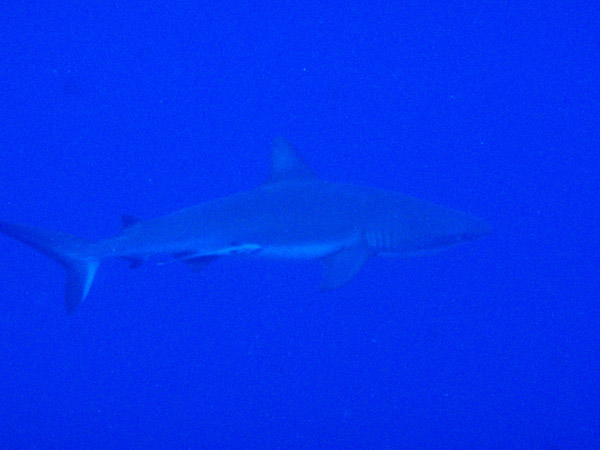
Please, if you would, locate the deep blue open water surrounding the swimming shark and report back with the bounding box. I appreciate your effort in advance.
[0,0,600,449]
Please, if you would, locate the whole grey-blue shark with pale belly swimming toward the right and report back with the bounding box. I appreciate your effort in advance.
[0,139,491,313]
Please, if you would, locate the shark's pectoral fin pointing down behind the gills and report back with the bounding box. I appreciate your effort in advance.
[321,246,371,290]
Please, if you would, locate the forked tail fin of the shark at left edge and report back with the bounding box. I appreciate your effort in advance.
[0,222,100,313]
